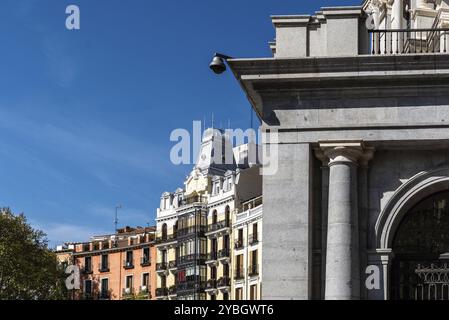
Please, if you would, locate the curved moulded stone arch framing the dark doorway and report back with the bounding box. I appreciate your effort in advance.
[375,166,449,250]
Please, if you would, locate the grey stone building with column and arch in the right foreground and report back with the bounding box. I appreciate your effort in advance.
[228,0,449,299]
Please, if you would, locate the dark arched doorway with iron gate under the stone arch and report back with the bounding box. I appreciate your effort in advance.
[390,190,449,300]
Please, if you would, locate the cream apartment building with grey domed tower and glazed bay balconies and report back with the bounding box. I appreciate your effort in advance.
[156,129,262,300]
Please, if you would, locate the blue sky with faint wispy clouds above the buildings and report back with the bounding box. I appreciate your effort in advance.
[0,0,361,245]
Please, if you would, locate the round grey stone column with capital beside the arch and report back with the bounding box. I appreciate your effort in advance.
[320,142,364,300]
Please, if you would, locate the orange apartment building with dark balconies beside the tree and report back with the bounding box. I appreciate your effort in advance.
[56,227,156,300]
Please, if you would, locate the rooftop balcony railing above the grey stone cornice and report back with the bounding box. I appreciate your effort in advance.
[369,28,449,55]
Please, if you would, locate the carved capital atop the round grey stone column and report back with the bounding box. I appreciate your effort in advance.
[315,141,374,167]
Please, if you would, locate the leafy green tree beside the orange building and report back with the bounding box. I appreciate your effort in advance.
[0,208,67,300]
